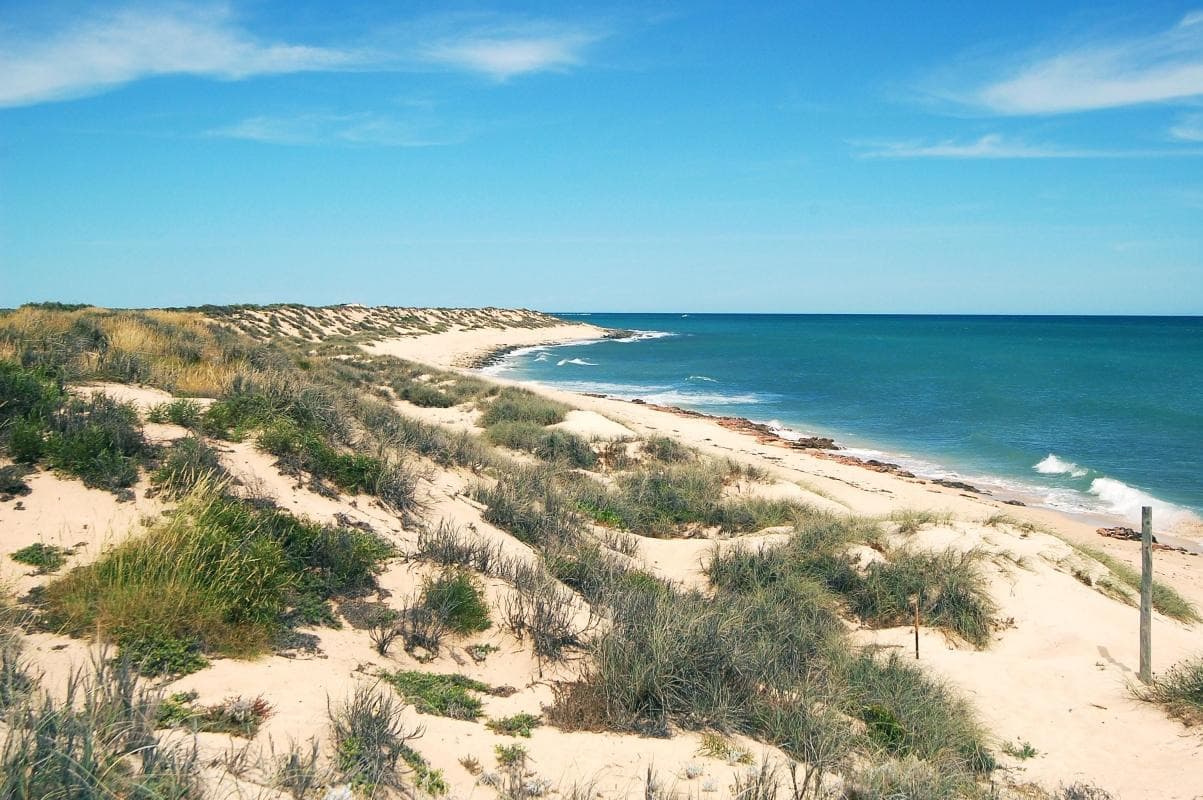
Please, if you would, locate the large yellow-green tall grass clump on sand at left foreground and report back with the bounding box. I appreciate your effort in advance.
[43,484,391,674]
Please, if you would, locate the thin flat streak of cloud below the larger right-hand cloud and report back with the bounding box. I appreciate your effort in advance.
[849,134,1199,159]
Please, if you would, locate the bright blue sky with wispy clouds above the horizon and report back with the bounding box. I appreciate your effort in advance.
[0,0,1203,314]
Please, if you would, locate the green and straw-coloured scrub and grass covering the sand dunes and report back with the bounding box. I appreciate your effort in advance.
[0,306,1174,800]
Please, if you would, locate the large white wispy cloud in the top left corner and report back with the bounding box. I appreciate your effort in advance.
[0,6,357,106]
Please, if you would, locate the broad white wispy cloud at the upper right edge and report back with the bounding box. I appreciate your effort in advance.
[962,11,1203,114]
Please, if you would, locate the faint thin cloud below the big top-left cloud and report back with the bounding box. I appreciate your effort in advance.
[207,113,463,147]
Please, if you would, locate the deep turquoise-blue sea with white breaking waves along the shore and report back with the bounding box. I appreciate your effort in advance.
[490,314,1203,528]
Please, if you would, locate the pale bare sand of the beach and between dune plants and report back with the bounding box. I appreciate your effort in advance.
[0,306,1203,800]
